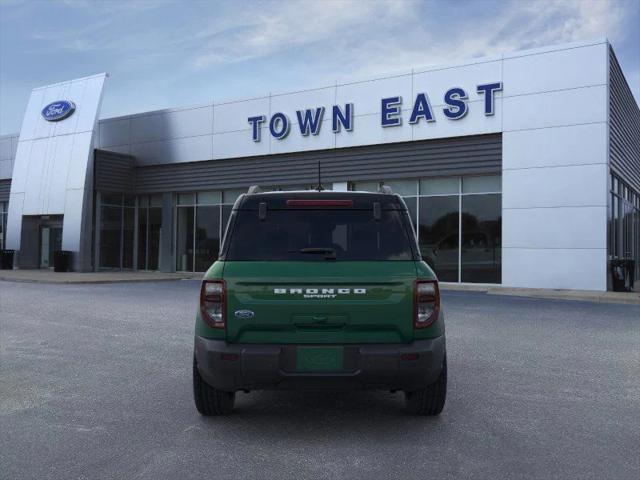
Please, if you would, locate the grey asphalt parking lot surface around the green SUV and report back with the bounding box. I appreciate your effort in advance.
[0,280,640,480]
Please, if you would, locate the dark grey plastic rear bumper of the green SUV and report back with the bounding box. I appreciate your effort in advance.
[195,335,445,391]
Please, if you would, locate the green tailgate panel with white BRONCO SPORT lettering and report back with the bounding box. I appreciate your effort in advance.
[224,261,416,344]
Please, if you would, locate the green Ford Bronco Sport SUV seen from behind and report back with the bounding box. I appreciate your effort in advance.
[193,187,447,415]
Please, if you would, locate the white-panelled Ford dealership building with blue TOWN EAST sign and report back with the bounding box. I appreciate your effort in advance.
[0,40,640,291]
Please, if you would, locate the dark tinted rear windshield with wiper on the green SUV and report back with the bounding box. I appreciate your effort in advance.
[226,209,413,261]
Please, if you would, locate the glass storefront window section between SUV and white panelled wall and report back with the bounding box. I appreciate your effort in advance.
[349,175,502,283]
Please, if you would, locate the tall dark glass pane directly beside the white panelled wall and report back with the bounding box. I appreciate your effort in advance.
[462,194,502,283]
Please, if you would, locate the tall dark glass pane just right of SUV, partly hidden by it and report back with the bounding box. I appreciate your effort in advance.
[419,195,459,282]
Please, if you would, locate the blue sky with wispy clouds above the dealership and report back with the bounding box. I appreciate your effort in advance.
[0,0,640,134]
